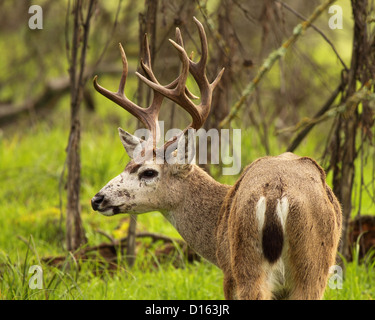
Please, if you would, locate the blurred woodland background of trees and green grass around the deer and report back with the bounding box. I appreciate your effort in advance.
[0,0,375,299]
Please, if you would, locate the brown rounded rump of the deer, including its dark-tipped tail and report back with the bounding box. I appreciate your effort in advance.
[217,153,341,299]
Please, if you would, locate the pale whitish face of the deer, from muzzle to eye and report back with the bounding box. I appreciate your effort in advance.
[93,163,162,216]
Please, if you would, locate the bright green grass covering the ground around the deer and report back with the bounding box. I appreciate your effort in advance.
[0,101,375,299]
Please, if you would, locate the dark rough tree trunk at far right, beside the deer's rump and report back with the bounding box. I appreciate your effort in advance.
[331,0,374,257]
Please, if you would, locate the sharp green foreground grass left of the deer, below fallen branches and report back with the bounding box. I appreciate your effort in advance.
[0,242,223,300]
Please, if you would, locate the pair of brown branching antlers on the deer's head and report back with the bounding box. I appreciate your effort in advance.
[94,17,224,159]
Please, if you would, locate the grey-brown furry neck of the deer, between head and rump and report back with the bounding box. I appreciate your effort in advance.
[163,166,230,265]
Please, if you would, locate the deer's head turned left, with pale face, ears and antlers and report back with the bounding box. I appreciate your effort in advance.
[91,18,224,215]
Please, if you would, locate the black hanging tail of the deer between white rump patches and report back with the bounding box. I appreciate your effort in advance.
[262,199,284,263]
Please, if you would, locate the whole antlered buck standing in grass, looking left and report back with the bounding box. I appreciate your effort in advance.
[91,17,342,300]
